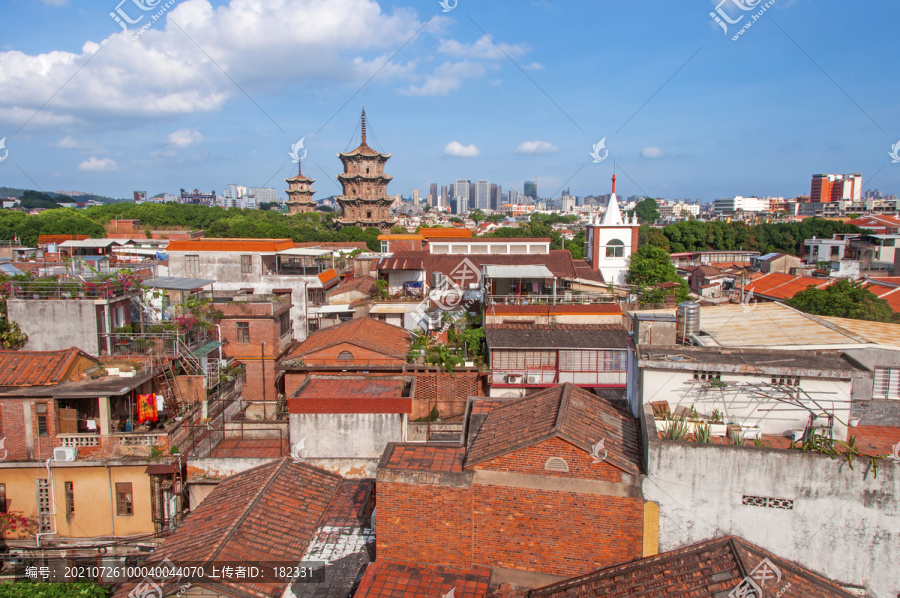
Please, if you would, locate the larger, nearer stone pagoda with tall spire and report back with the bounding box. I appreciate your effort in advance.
[336,107,394,231]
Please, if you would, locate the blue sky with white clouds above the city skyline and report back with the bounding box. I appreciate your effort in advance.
[0,0,900,200]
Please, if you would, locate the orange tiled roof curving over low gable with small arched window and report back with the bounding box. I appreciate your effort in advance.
[288,318,412,359]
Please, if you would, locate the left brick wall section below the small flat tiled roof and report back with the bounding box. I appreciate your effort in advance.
[376,481,472,569]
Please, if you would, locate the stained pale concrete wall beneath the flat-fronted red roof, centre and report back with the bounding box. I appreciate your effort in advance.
[290,413,406,460]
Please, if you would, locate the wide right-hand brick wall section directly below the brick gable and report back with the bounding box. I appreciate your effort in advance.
[474,484,643,577]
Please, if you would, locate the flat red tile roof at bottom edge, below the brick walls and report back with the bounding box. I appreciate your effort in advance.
[354,559,491,598]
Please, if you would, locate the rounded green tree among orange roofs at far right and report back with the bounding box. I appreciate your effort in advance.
[785,280,896,322]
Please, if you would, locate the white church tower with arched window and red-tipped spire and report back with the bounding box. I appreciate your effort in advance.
[585,174,639,285]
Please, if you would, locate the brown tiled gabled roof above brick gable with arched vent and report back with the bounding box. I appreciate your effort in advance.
[466,384,641,474]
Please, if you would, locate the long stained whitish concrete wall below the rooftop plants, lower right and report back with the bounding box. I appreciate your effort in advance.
[643,440,900,598]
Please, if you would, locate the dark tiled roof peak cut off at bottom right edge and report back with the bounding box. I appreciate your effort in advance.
[527,536,852,598]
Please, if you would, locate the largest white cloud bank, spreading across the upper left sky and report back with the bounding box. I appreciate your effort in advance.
[0,0,421,127]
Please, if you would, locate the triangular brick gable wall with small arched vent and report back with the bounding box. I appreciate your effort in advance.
[472,438,623,482]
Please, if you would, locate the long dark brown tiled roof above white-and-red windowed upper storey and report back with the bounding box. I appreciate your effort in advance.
[484,324,630,349]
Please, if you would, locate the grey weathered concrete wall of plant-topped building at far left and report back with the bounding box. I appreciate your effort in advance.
[6,299,102,355]
